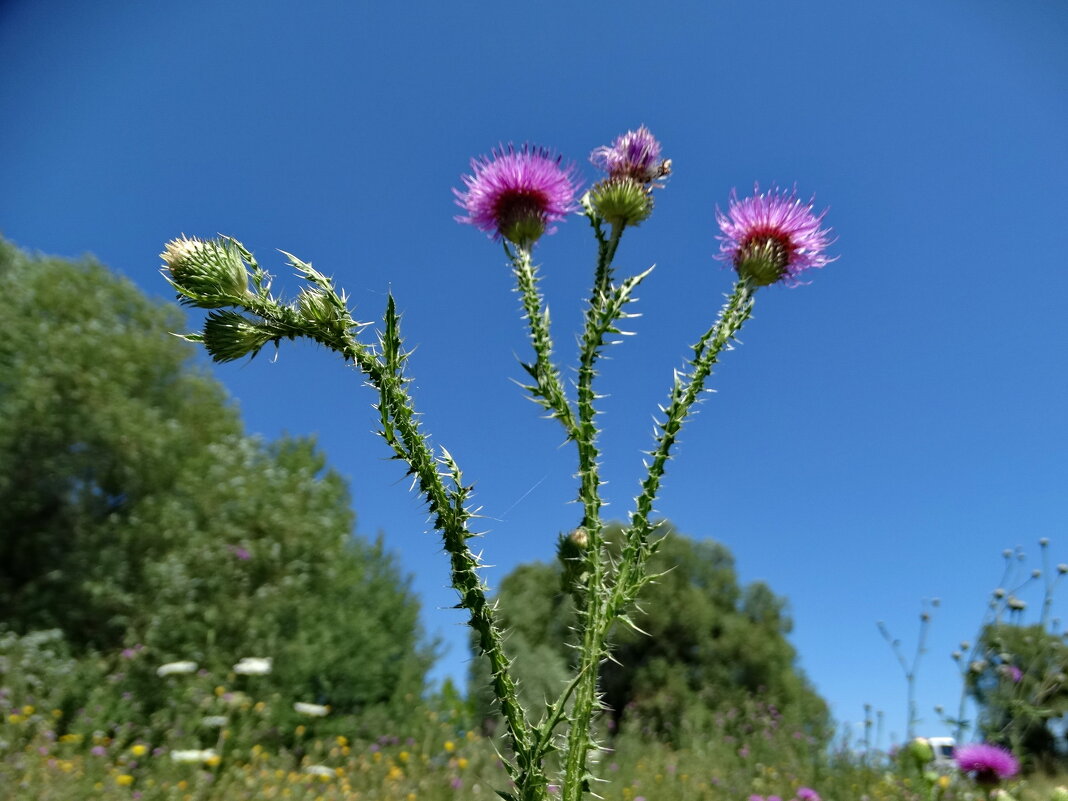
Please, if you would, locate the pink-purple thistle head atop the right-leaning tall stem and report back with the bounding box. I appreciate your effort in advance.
[716,185,834,286]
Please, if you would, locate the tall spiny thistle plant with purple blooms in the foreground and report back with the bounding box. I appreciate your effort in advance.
[162,127,831,801]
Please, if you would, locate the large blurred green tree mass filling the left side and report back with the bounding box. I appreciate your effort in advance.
[0,239,433,711]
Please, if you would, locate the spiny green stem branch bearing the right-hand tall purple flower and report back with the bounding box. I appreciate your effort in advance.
[610,279,756,616]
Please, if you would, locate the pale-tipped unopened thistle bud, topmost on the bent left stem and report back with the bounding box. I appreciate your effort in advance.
[159,236,249,309]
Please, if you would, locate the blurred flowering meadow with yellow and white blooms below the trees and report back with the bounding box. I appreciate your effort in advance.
[0,632,1062,801]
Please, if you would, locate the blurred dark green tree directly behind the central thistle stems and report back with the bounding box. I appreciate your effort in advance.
[472,522,831,742]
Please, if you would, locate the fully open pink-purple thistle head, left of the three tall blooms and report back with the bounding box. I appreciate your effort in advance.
[453,144,580,248]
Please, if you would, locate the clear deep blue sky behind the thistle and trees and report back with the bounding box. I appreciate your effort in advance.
[0,0,1068,751]
